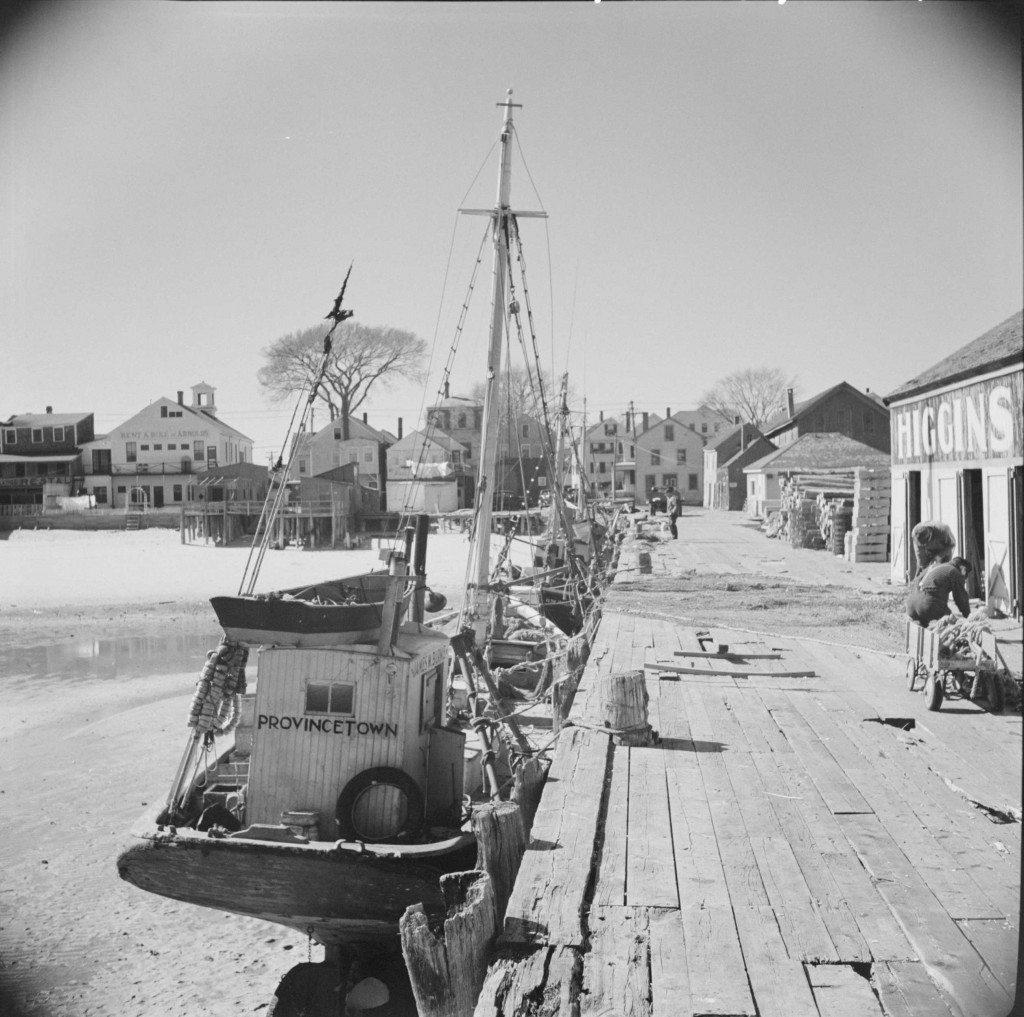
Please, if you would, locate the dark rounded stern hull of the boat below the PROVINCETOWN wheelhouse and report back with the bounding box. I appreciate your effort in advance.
[118,828,476,943]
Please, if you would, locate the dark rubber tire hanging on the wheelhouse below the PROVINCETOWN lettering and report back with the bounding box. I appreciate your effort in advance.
[335,766,424,843]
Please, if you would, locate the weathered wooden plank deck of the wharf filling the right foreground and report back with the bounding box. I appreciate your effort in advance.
[476,610,1021,1017]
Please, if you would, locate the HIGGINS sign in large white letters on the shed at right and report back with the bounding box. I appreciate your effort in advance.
[891,372,1022,465]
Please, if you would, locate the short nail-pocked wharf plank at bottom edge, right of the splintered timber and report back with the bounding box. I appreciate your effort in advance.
[580,907,652,1017]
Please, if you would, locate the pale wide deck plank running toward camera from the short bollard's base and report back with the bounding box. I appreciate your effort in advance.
[612,748,679,907]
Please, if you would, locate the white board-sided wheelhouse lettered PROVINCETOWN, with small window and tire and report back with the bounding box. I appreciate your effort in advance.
[245,623,465,842]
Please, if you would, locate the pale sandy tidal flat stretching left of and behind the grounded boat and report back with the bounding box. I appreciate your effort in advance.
[0,529,499,1017]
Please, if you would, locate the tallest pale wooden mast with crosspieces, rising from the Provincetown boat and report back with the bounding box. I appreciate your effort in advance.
[467,88,519,641]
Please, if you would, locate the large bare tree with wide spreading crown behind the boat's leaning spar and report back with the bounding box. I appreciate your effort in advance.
[257,322,427,439]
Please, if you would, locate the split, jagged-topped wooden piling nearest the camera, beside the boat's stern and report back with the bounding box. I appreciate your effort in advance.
[398,870,498,1017]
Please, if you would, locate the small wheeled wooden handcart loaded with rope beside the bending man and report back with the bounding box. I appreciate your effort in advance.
[906,619,1002,713]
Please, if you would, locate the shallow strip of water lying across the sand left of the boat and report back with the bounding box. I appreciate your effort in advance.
[0,629,221,691]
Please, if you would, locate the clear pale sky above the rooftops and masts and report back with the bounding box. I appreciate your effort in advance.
[0,0,1024,462]
